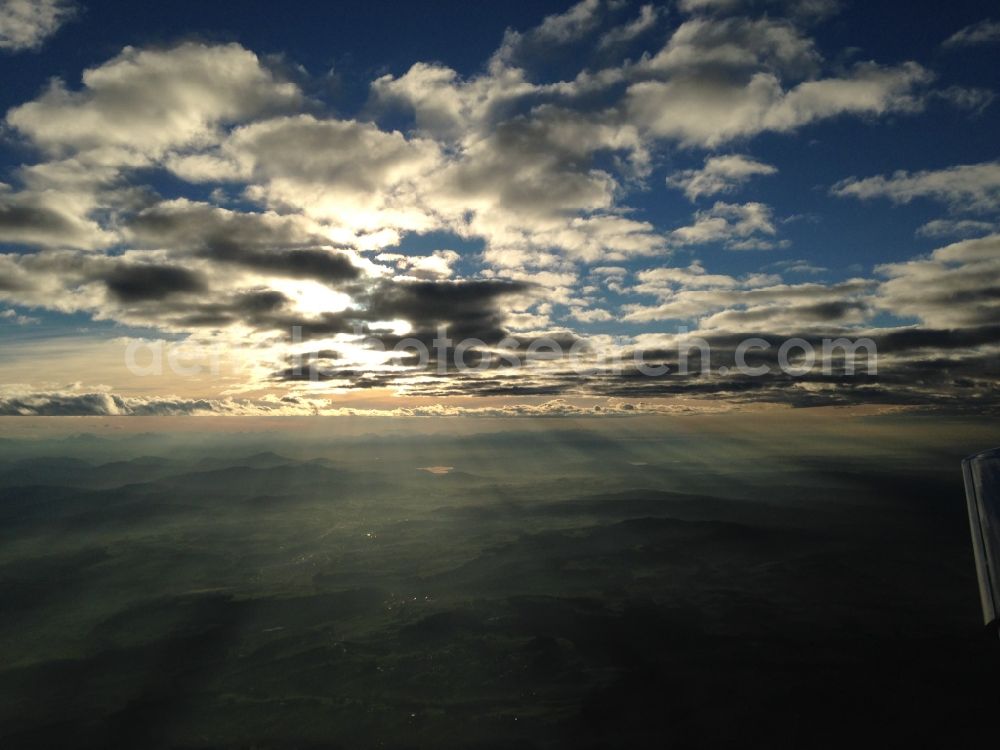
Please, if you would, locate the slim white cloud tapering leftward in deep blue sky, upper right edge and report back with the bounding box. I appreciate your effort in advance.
[831,162,1000,212]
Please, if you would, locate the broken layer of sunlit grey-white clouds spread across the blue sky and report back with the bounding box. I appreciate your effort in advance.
[0,0,1000,414]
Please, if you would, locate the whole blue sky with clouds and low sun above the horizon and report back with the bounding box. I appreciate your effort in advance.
[0,0,1000,416]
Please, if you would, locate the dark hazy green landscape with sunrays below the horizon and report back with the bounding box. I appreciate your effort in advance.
[0,417,1000,748]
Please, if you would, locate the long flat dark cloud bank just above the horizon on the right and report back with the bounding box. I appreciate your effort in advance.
[340,318,1000,413]
